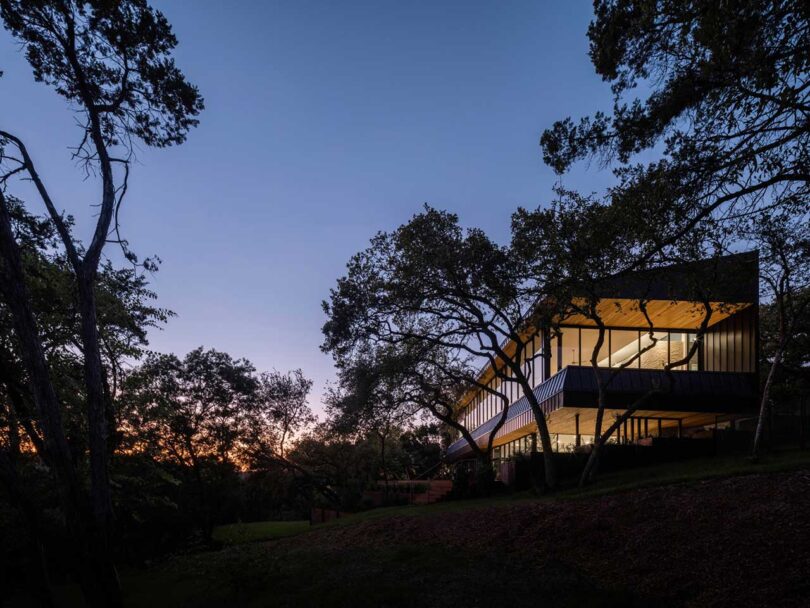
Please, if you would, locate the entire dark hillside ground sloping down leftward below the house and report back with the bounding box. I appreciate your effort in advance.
[33,452,810,607]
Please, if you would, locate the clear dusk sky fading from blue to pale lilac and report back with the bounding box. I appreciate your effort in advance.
[0,0,610,416]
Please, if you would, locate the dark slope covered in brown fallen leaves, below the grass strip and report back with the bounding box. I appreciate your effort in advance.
[288,470,810,606]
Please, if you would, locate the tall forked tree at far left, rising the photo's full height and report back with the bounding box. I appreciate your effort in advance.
[0,0,203,606]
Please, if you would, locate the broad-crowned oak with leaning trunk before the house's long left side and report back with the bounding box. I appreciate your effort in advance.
[322,206,556,487]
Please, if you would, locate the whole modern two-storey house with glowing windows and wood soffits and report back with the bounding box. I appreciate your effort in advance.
[447,252,759,462]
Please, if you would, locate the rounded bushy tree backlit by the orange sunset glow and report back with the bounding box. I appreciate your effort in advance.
[120,347,313,541]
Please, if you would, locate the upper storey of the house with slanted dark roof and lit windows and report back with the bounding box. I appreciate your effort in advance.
[456,252,759,429]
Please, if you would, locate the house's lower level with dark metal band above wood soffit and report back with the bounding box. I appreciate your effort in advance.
[448,366,758,462]
